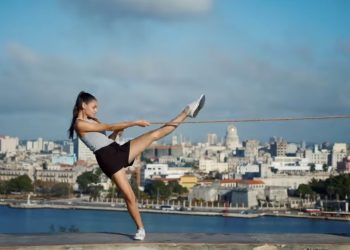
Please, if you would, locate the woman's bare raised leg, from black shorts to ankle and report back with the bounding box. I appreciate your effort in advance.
[129,110,187,162]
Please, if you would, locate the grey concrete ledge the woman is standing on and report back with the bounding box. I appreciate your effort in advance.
[0,233,350,250]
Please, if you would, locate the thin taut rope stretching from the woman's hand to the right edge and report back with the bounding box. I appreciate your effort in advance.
[151,115,350,125]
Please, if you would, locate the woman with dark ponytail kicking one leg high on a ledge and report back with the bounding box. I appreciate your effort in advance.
[68,91,205,240]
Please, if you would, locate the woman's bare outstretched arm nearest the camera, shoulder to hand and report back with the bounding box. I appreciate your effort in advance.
[75,120,150,133]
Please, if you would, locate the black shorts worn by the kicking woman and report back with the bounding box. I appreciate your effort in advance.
[94,141,134,179]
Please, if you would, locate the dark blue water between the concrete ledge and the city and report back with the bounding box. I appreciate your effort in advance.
[0,206,350,234]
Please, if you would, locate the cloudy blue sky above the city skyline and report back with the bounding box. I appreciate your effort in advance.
[0,0,350,142]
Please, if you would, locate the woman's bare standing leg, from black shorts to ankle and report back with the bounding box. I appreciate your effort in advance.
[112,168,144,229]
